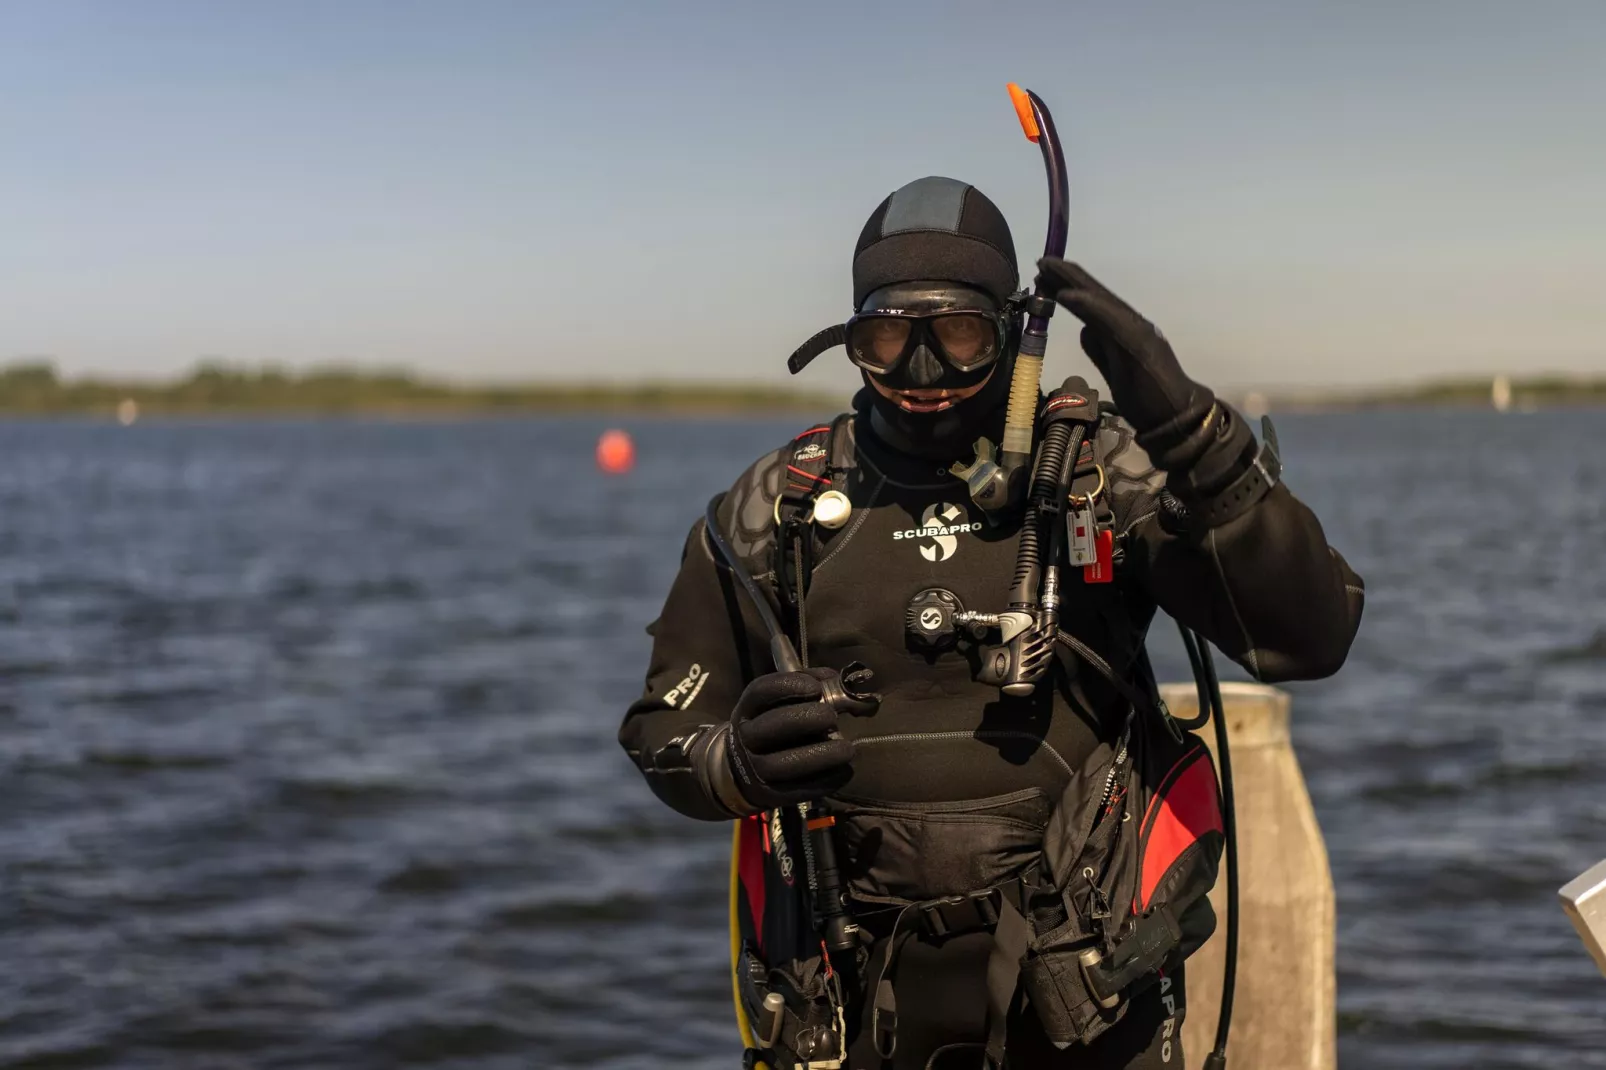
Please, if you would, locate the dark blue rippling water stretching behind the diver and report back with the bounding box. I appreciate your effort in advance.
[0,411,1606,1070]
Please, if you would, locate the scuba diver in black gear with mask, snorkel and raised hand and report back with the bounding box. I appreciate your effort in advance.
[620,87,1363,1070]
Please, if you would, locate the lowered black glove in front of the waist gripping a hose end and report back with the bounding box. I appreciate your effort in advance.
[726,667,880,810]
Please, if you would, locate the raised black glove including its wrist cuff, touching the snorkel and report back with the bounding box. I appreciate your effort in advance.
[1037,257,1254,501]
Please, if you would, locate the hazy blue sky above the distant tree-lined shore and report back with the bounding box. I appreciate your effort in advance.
[0,0,1606,387]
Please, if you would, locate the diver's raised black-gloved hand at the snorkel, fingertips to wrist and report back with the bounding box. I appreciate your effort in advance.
[1037,257,1216,435]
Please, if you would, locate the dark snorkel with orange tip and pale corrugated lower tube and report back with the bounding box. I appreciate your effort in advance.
[949,82,1071,517]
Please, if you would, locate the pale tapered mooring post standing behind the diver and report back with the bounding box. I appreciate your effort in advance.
[1161,683,1338,1070]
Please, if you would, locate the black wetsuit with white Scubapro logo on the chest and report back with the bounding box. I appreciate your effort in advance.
[620,401,1362,1070]
